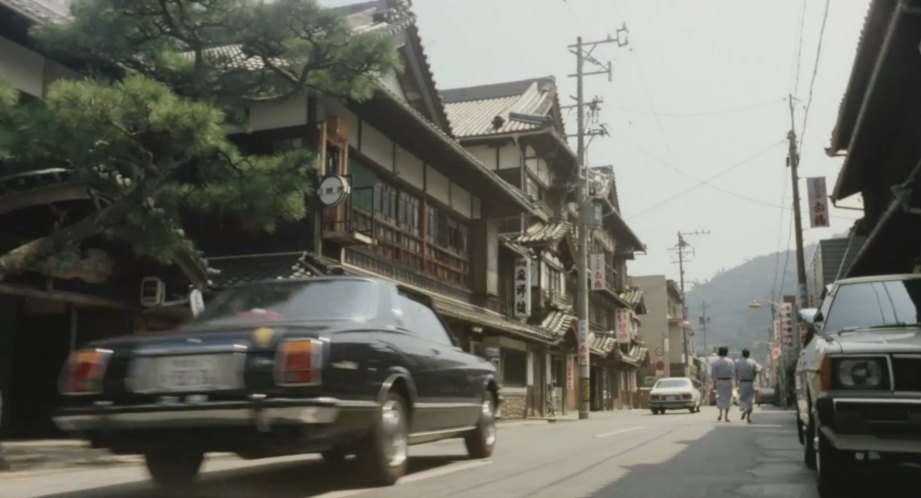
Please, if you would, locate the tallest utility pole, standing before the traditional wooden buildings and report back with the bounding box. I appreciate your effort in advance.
[569,25,628,419]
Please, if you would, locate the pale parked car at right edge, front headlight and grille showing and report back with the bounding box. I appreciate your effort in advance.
[796,275,921,498]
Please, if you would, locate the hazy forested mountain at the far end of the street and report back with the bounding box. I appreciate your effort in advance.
[688,244,817,360]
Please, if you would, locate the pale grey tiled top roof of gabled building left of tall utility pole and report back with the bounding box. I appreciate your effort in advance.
[441,77,557,138]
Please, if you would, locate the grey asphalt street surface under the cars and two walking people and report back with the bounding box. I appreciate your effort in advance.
[0,408,921,498]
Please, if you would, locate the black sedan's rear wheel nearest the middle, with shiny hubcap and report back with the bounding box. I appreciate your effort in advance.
[358,393,409,486]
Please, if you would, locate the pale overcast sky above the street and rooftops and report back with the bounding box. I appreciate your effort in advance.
[321,0,869,287]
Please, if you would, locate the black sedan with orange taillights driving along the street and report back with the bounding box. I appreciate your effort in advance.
[55,277,500,489]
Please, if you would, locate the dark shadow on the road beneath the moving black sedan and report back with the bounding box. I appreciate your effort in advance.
[33,455,466,498]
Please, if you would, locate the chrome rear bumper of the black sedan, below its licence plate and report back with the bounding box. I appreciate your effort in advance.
[54,398,378,432]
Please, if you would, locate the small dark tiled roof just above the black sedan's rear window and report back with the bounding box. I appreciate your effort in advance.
[206,252,316,289]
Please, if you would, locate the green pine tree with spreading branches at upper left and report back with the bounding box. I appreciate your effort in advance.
[0,0,399,280]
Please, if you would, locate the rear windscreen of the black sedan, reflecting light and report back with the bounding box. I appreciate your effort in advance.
[192,280,379,326]
